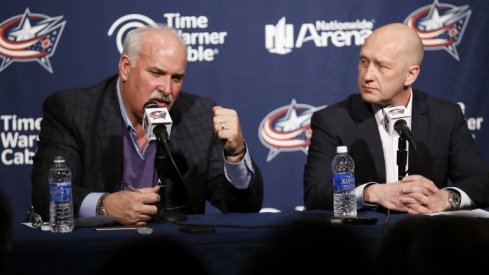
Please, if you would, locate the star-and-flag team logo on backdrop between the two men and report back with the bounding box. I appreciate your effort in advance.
[258,99,326,162]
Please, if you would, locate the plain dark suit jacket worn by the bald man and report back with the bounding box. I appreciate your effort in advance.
[304,91,489,210]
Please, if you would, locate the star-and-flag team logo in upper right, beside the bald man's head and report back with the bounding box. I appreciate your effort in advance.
[404,0,472,61]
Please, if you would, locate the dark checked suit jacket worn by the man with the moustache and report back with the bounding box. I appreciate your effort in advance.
[32,76,263,218]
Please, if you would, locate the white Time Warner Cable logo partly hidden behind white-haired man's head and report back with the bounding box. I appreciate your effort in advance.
[107,13,228,62]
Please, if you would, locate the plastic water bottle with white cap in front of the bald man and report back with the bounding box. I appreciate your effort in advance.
[331,146,357,217]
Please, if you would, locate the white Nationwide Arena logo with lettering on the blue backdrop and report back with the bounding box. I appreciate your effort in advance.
[265,17,374,55]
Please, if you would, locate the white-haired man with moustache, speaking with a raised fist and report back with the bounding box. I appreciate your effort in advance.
[32,25,263,225]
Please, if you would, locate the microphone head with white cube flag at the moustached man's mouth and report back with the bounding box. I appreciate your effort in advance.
[143,100,173,142]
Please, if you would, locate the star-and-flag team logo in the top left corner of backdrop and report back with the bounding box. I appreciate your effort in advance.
[0,8,66,73]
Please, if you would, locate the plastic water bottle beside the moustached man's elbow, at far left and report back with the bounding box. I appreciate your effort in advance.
[48,156,75,233]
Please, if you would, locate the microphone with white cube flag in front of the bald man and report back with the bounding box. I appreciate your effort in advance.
[382,106,416,149]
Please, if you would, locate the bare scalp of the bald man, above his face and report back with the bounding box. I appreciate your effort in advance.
[365,23,424,67]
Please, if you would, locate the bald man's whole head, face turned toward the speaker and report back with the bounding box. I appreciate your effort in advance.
[358,23,423,106]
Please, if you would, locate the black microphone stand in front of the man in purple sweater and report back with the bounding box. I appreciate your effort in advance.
[155,127,187,223]
